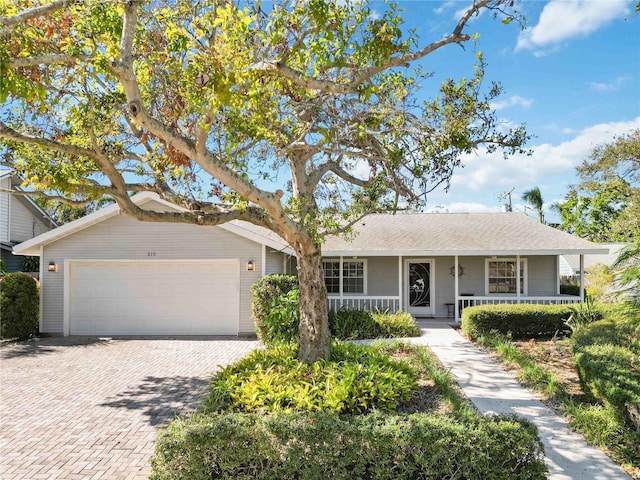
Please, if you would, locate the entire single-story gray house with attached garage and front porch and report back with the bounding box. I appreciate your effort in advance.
[14,193,606,335]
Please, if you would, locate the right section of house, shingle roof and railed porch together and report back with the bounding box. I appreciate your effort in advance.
[323,213,606,319]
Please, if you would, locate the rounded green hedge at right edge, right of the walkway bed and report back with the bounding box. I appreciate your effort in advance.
[572,317,640,418]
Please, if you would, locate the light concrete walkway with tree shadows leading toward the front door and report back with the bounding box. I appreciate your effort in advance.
[411,320,631,480]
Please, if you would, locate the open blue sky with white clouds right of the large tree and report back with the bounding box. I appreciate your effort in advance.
[390,0,640,222]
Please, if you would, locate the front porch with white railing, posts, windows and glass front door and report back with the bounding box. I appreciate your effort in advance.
[325,255,584,322]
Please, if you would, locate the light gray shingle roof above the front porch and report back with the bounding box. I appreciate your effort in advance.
[323,213,606,256]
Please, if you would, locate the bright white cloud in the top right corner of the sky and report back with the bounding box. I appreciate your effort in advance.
[516,0,631,54]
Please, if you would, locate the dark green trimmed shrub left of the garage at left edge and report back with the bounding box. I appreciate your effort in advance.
[0,273,40,340]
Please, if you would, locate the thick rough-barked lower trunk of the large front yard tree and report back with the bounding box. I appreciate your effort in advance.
[297,247,331,363]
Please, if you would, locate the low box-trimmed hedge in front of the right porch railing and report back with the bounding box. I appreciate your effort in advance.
[461,304,572,339]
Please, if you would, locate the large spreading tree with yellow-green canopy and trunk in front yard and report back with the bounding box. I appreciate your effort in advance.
[0,0,526,362]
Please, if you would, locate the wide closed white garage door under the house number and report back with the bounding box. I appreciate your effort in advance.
[67,260,240,335]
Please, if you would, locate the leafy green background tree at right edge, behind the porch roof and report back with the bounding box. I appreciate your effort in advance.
[555,130,640,242]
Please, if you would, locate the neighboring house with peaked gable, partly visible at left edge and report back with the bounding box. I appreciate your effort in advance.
[0,169,56,272]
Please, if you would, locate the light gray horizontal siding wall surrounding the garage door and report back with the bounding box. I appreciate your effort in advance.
[41,212,262,334]
